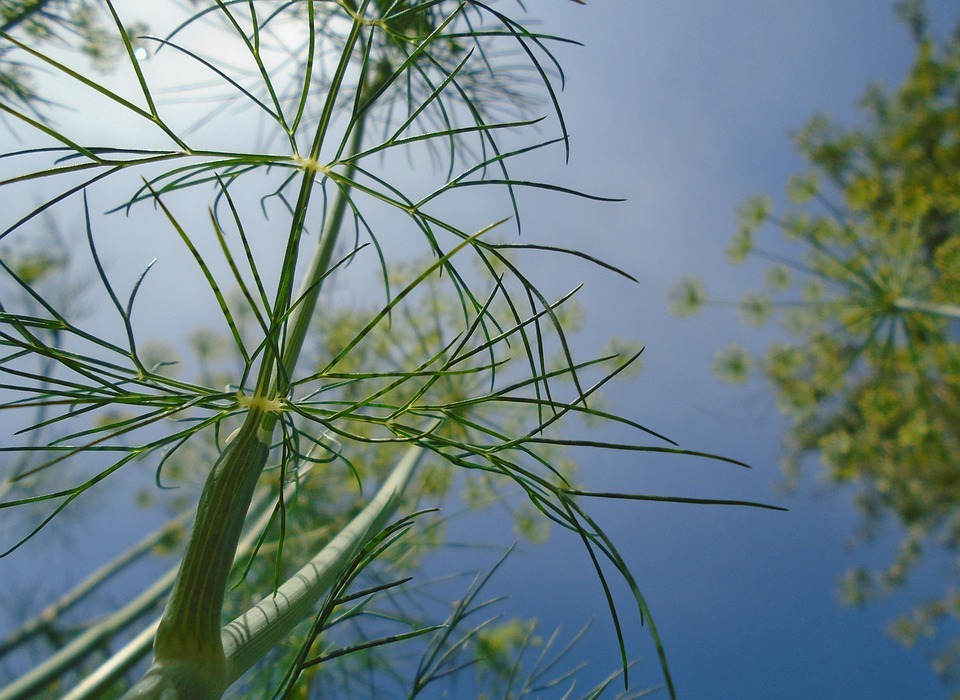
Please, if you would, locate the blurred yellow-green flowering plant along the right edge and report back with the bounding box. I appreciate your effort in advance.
[671,2,960,679]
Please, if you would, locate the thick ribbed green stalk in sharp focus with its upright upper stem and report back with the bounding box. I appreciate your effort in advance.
[120,9,386,700]
